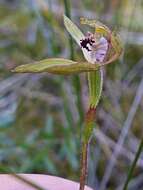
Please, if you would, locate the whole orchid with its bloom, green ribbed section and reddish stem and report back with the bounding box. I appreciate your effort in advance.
[13,16,122,190]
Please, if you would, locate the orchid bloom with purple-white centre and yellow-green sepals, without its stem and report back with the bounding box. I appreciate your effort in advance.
[13,15,122,75]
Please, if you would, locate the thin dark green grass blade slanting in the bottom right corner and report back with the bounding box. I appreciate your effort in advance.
[123,138,143,190]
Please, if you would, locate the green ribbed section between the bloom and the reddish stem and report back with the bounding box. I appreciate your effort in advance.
[88,68,103,108]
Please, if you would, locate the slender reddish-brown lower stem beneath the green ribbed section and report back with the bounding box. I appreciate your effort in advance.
[79,107,96,190]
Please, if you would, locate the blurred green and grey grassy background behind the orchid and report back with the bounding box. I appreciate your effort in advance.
[0,0,143,190]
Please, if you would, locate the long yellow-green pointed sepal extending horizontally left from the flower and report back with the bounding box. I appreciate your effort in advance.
[12,58,100,75]
